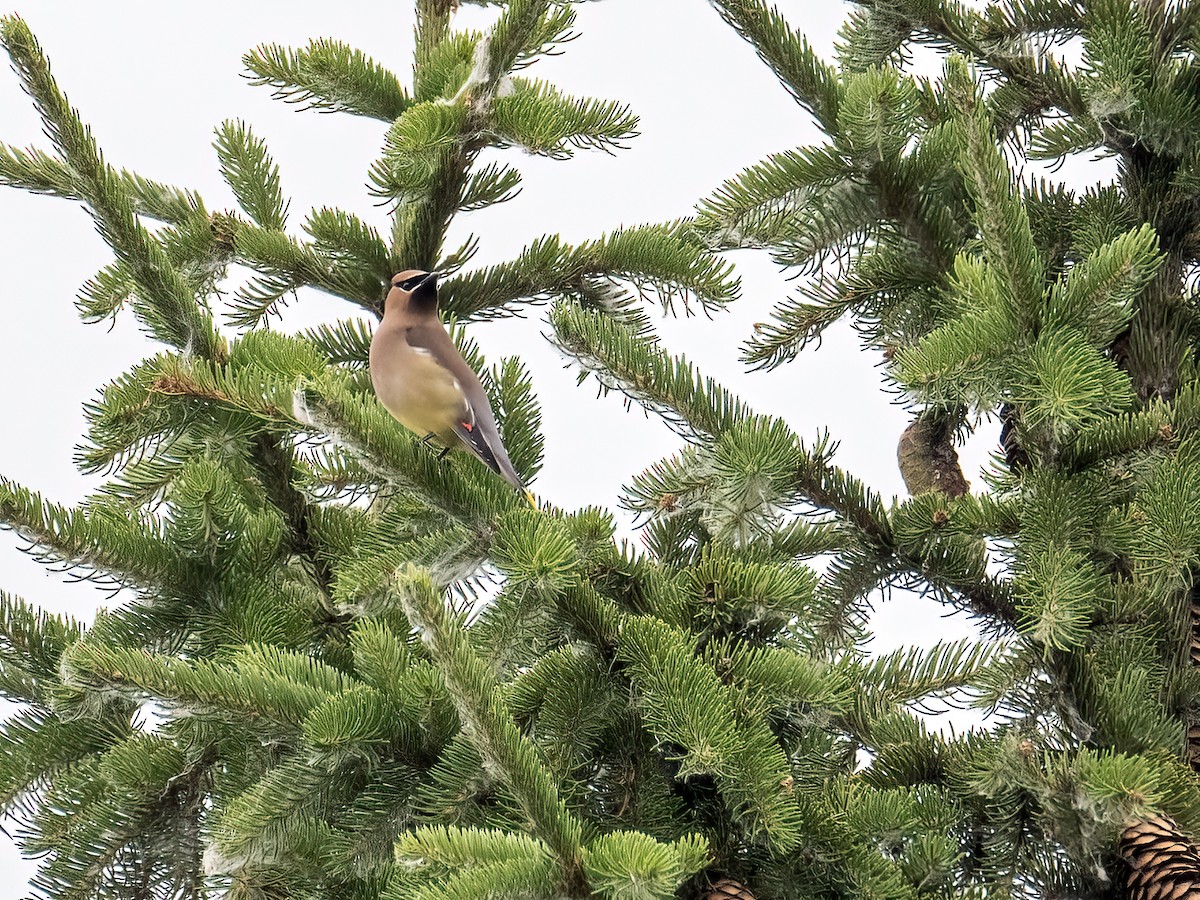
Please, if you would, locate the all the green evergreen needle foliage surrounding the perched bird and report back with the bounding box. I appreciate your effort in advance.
[7,0,1200,900]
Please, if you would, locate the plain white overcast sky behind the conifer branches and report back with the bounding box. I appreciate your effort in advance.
[0,0,996,898]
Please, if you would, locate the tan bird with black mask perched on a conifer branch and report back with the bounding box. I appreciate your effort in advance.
[370,269,536,506]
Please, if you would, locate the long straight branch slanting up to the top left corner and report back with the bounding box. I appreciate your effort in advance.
[0,17,223,358]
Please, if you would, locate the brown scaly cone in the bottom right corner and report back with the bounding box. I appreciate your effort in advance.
[1120,816,1200,900]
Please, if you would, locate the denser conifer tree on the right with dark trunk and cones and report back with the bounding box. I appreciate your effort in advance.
[696,0,1200,898]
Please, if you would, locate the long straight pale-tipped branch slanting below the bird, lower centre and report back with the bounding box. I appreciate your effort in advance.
[392,566,583,884]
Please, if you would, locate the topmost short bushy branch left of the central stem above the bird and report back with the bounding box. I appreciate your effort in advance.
[242,38,413,122]
